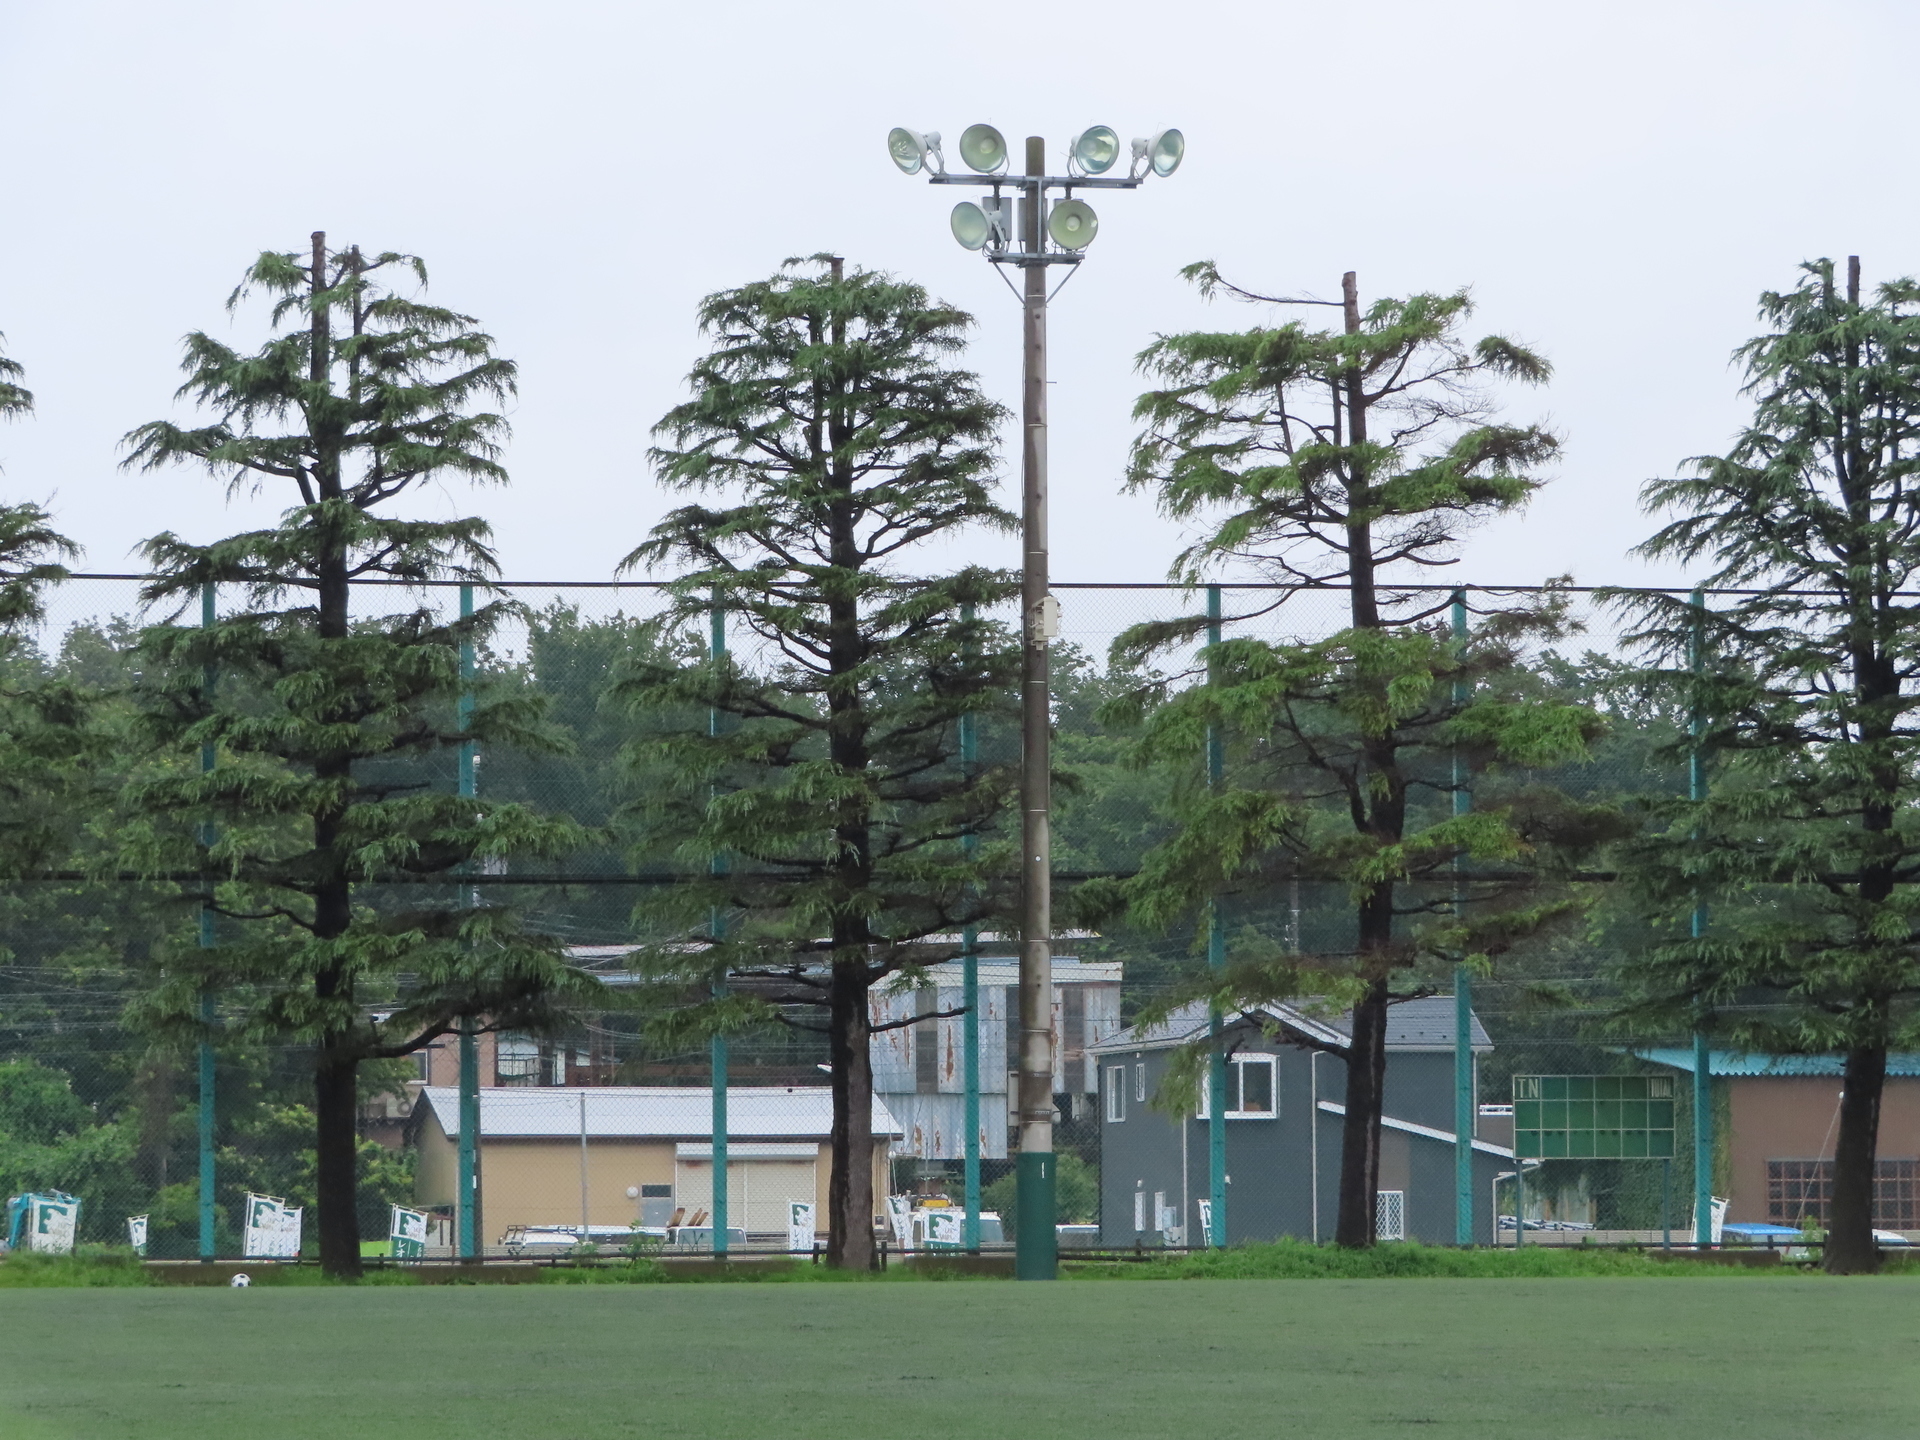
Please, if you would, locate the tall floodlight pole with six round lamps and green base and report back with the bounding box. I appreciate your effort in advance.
[887,125,1187,1281]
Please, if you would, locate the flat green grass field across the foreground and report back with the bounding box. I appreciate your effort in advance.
[0,1277,1920,1440]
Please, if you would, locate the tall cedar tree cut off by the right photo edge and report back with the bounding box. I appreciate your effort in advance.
[1628,259,1920,1273]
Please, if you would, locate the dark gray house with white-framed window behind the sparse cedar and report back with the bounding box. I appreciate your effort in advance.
[1089,995,1513,1246]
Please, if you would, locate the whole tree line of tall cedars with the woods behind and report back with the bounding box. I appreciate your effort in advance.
[0,234,1920,1275]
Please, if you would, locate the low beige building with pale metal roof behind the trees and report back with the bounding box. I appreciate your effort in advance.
[413,1085,900,1244]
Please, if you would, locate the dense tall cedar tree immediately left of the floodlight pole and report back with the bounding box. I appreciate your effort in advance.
[616,255,1018,1269]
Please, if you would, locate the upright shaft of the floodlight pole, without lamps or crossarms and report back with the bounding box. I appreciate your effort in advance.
[1014,136,1058,1281]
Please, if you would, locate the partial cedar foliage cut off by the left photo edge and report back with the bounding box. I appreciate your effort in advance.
[0,341,96,876]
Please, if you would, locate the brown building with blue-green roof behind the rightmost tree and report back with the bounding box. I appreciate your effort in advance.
[1642,1050,1920,1233]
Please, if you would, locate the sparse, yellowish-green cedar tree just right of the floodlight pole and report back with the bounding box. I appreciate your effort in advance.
[1089,265,1599,1246]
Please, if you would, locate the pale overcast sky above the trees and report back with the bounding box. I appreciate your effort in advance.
[0,0,1920,599]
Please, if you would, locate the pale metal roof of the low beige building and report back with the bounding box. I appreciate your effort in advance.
[415,1085,904,1142]
